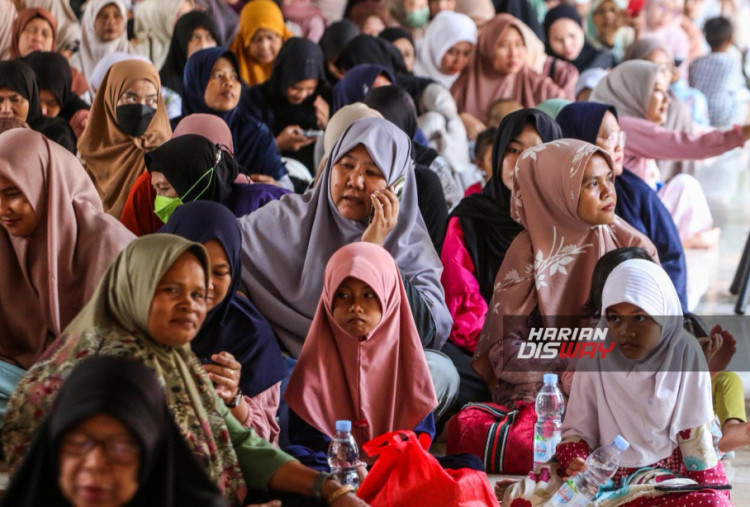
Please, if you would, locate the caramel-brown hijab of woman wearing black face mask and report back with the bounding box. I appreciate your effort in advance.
[78,60,172,218]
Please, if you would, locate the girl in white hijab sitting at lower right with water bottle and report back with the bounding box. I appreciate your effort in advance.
[503,259,731,507]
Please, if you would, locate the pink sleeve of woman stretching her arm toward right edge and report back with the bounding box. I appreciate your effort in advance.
[620,116,745,187]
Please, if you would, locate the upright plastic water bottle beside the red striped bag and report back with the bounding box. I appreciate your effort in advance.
[534,373,565,468]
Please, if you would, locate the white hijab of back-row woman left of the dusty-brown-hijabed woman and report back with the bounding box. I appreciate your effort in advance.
[414,11,477,90]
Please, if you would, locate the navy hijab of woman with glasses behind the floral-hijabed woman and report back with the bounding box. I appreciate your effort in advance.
[557,102,687,311]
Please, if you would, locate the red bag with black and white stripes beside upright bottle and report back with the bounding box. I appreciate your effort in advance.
[445,401,537,475]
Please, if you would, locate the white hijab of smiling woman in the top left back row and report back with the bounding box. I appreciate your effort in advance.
[71,0,137,80]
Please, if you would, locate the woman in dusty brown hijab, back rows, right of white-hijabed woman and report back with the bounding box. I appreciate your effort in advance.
[451,14,566,130]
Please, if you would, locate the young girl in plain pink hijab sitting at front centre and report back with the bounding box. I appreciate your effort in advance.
[284,243,437,462]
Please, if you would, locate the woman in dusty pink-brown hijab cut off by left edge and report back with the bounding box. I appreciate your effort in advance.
[0,129,135,369]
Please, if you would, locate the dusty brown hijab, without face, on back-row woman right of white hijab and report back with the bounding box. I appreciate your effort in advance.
[451,14,567,122]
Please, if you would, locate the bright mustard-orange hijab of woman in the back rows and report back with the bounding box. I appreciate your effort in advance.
[229,0,293,86]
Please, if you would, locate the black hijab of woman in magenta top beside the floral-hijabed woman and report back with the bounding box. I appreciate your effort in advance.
[451,109,562,303]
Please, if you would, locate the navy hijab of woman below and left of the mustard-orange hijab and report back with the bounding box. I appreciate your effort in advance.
[182,47,287,180]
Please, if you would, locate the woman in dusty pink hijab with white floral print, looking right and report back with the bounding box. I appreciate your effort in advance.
[473,139,658,403]
